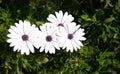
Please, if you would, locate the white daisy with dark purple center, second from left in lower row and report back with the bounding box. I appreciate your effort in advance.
[39,23,60,54]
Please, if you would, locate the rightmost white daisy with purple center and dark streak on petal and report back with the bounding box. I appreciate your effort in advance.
[58,22,86,52]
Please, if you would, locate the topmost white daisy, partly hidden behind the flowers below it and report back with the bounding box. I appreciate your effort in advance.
[47,11,74,27]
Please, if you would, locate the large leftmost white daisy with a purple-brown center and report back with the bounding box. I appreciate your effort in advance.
[7,20,39,55]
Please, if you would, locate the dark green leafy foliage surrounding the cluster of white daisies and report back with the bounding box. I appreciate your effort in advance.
[0,0,120,74]
